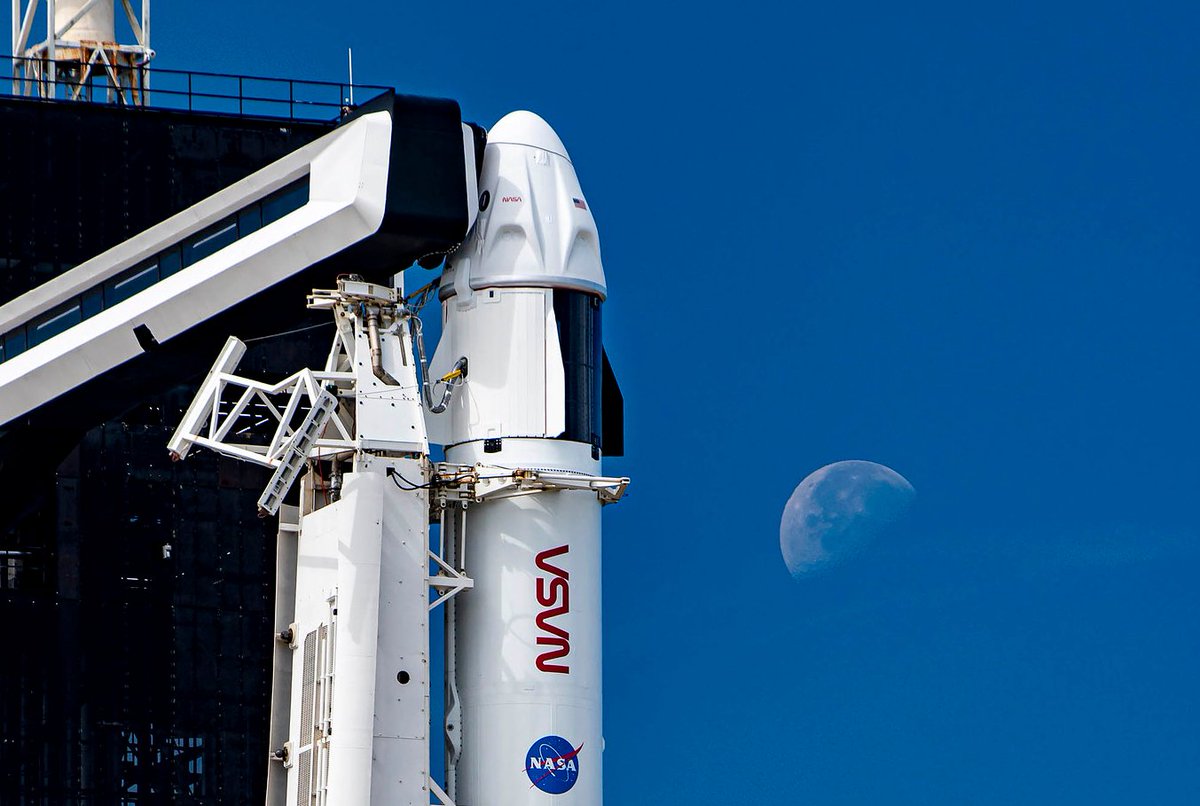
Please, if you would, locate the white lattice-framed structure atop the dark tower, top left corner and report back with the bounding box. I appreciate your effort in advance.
[12,0,155,106]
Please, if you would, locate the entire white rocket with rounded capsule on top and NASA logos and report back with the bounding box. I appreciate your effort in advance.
[427,112,623,806]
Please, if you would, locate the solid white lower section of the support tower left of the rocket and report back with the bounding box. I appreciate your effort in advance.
[286,465,430,806]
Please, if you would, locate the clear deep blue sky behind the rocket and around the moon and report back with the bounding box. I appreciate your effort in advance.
[155,1,1200,806]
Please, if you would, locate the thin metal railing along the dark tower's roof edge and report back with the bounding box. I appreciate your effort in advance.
[0,55,392,120]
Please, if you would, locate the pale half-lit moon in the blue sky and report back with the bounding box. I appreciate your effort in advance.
[779,459,917,579]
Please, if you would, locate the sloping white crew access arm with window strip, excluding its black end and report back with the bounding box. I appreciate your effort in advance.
[0,112,392,426]
